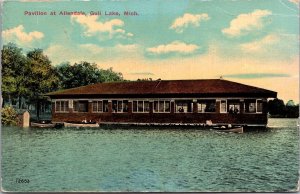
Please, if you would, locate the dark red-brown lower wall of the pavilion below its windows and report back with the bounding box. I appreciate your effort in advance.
[52,101,267,125]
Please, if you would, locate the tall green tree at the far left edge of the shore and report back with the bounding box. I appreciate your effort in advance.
[1,43,28,108]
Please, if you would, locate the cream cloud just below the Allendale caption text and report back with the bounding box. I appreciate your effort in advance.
[71,15,133,39]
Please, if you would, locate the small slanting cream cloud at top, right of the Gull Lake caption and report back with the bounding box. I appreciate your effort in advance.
[170,13,210,33]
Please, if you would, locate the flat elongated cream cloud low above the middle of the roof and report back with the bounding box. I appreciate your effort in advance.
[147,41,199,54]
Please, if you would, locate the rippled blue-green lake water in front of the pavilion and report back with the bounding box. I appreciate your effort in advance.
[2,119,299,192]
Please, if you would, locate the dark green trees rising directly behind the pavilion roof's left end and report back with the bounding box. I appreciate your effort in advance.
[56,61,123,89]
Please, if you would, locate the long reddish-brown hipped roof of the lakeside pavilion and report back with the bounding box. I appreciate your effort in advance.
[46,79,277,97]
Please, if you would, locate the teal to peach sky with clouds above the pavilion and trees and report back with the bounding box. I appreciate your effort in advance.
[2,0,299,103]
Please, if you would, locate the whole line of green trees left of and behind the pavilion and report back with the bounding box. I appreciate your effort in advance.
[1,43,123,118]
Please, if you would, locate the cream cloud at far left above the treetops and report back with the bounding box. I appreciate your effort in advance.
[2,25,44,46]
